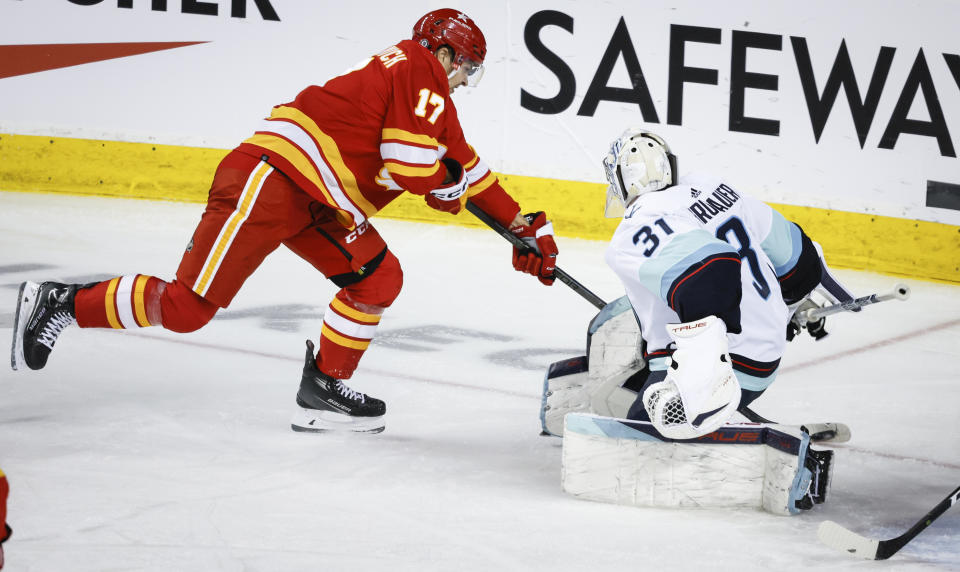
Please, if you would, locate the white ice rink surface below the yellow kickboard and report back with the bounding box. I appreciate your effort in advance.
[0,193,960,572]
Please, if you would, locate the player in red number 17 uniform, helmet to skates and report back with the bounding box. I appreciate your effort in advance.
[11,9,557,432]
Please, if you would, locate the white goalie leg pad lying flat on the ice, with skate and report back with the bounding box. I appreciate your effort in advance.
[562,413,833,515]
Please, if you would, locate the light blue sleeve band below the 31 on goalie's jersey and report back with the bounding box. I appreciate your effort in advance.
[640,229,740,302]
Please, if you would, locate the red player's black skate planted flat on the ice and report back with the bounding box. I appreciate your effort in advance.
[290,340,387,433]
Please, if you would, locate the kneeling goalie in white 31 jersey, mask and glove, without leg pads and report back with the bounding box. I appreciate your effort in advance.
[604,129,852,439]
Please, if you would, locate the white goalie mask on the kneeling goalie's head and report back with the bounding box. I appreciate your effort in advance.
[603,128,677,218]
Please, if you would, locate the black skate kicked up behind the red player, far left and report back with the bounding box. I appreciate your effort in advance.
[10,282,80,370]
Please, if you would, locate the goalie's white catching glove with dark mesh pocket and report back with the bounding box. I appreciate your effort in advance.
[643,316,740,439]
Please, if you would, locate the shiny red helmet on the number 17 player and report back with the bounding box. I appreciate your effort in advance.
[413,8,487,67]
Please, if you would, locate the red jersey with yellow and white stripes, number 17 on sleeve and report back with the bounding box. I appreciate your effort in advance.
[237,40,520,228]
